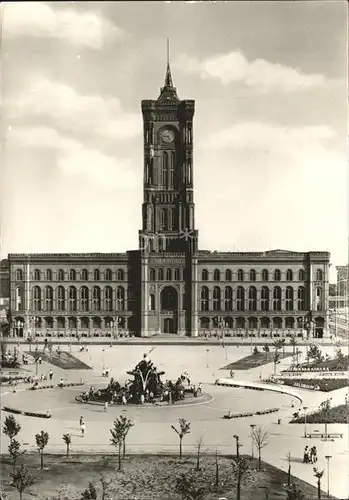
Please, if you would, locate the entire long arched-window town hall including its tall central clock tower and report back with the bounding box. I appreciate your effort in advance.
[8,61,330,337]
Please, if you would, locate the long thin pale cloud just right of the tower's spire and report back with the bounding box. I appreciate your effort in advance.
[174,51,326,92]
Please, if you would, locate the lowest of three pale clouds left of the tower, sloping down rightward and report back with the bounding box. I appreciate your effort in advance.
[6,126,139,189]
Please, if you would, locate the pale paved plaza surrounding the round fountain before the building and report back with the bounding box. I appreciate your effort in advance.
[1,345,349,499]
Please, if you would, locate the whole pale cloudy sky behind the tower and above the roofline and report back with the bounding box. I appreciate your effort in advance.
[0,1,348,282]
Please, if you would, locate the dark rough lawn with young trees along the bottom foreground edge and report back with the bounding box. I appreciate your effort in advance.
[1,454,334,500]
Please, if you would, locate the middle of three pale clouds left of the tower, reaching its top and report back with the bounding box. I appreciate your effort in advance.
[7,77,142,140]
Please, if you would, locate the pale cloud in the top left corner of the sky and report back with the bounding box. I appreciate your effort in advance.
[3,2,126,49]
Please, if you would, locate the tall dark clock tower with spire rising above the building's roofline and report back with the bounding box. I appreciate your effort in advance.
[139,63,198,253]
